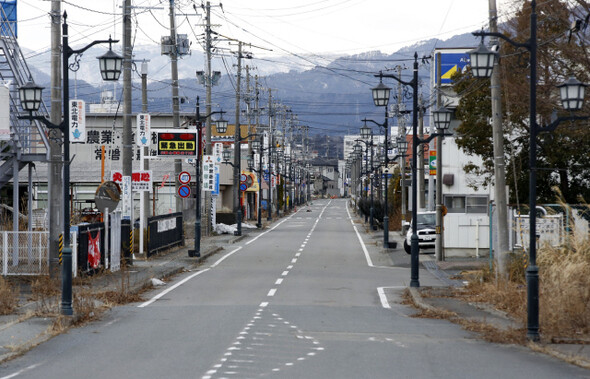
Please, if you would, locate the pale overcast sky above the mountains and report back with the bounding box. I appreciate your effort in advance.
[18,0,513,59]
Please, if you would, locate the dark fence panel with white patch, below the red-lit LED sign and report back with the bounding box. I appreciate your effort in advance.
[147,212,184,257]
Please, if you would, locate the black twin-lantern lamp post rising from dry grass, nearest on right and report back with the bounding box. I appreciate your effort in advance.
[469,0,588,341]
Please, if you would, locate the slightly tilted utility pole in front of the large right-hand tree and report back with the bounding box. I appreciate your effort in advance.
[489,0,510,276]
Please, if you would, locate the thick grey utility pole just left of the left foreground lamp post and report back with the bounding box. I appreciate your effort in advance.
[48,0,63,278]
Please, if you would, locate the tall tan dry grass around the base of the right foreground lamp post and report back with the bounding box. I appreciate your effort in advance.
[456,209,590,343]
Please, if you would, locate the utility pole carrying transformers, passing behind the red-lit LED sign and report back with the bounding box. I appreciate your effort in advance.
[169,0,182,212]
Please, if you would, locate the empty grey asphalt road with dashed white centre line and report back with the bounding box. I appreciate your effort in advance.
[0,199,590,379]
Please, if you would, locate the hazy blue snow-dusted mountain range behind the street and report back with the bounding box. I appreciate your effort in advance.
[22,34,479,135]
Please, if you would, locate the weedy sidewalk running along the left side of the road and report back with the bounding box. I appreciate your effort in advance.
[0,222,267,363]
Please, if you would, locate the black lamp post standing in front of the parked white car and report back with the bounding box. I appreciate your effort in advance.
[373,53,454,287]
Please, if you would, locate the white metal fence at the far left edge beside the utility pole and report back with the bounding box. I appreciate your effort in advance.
[0,231,49,276]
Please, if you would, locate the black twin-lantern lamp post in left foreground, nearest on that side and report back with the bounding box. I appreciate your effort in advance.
[19,12,123,316]
